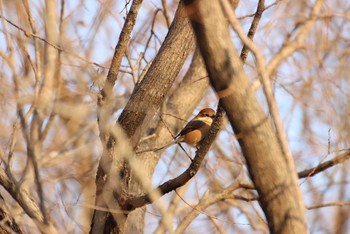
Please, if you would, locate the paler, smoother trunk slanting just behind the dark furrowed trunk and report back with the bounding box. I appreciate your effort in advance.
[126,48,209,233]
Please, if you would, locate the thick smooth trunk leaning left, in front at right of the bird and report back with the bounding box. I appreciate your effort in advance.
[185,0,306,233]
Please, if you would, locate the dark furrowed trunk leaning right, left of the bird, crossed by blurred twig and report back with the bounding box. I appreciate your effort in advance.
[90,1,194,233]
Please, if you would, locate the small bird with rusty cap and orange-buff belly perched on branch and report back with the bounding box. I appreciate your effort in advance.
[155,108,216,151]
